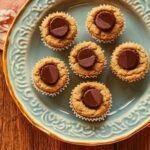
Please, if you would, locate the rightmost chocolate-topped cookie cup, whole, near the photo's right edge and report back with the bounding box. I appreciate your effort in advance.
[111,42,149,82]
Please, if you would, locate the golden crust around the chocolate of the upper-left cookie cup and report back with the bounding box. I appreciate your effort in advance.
[40,12,77,49]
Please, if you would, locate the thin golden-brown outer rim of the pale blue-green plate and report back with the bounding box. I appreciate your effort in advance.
[3,0,150,146]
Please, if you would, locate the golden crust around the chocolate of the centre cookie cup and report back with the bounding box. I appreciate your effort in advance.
[69,42,106,77]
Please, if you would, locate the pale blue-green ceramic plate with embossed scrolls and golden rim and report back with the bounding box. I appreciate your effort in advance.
[4,0,150,145]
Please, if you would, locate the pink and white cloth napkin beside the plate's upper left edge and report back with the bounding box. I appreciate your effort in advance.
[0,0,26,50]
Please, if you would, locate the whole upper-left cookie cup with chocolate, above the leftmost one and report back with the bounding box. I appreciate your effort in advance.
[40,12,77,51]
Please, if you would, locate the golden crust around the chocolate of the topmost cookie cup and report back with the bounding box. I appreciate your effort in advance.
[86,5,125,42]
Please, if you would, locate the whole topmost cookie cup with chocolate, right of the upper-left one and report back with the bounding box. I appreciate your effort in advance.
[86,5,125,43]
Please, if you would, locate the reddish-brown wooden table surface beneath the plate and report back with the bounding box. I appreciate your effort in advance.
[0,53,150,150]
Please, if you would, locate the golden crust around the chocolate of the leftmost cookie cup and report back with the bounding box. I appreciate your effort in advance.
[32,57,69,94]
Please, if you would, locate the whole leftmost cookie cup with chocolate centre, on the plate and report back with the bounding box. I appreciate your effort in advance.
[32,57,69,96]
